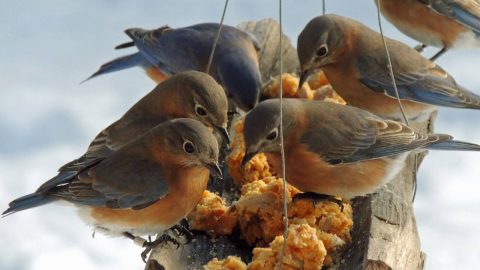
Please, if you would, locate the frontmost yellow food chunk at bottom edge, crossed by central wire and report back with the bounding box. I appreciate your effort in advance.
[247,224,327,270]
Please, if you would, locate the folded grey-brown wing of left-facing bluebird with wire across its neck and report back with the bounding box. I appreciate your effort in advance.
[300,104,450,164]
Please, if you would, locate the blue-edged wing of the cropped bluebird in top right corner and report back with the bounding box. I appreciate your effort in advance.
[427,0,480,36]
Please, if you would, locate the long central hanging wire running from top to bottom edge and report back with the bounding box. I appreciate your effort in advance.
[278,0,288,269]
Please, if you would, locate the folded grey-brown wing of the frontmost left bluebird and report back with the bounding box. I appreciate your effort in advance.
[52,149,169,209]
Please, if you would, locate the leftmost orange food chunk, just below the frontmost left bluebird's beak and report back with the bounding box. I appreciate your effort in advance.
[187,190,238,236]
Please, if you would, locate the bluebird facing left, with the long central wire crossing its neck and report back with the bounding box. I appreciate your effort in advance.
[242,99,480,199]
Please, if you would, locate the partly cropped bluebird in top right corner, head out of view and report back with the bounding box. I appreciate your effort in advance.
[374,0,480,61]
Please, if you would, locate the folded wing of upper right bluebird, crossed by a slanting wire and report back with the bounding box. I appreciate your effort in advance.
[356,39,480,108]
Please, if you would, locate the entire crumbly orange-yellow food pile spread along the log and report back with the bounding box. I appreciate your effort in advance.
[197,72,353,269]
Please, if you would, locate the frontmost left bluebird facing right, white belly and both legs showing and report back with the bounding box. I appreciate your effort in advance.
[2,118,221,262]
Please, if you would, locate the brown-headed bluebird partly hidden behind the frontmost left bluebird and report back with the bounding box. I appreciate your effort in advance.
[37,71,228,201]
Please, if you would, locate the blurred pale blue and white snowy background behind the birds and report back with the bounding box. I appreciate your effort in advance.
[0,0,480,270]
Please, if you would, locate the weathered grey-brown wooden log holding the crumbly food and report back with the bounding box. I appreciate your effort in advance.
[145,19,426,270]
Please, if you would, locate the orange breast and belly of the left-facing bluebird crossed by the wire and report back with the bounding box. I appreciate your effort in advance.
[267,145,404,199]
